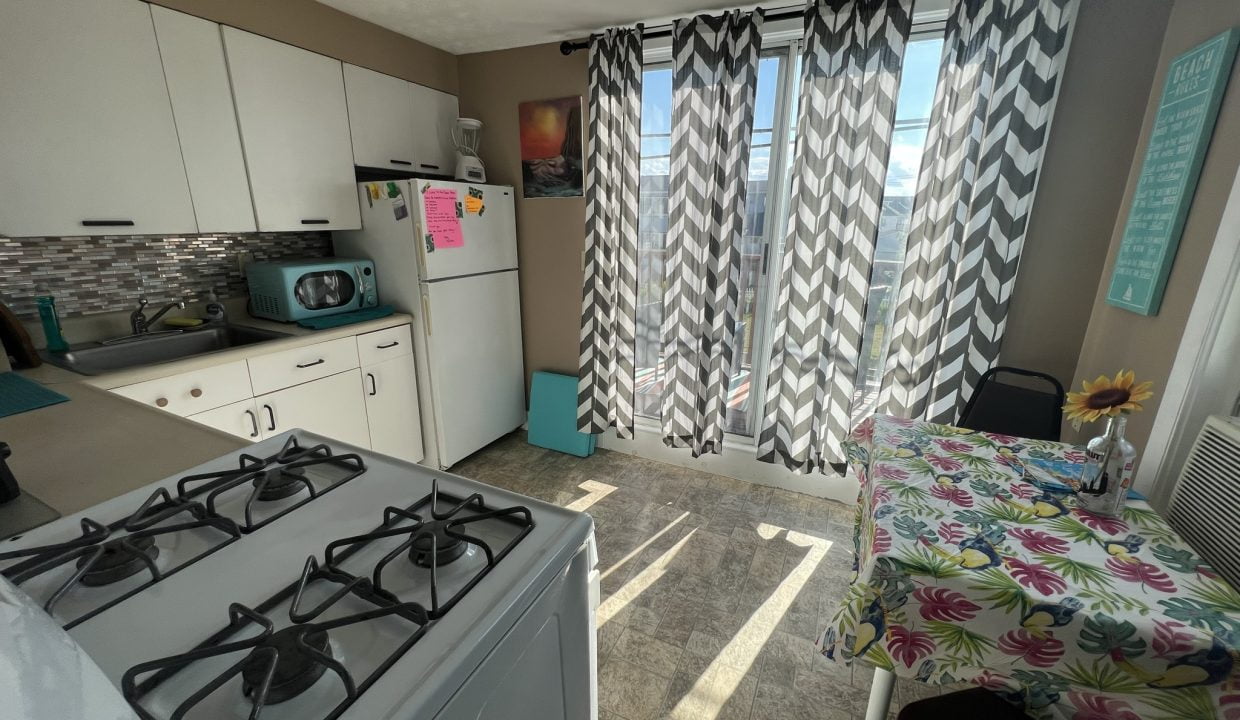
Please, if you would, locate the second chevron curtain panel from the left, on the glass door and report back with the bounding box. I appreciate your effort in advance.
[662,10,763,457]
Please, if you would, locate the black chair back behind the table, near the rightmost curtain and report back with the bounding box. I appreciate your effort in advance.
[956,367,1064,440]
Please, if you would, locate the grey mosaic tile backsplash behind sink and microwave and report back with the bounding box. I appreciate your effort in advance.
[0,233,331,317]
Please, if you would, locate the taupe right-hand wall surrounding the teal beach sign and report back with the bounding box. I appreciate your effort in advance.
[1076,0,1240,449]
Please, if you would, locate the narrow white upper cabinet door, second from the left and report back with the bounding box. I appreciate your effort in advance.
[151,5,255,233]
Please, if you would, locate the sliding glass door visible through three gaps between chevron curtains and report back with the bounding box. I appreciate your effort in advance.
[635,30,942,442]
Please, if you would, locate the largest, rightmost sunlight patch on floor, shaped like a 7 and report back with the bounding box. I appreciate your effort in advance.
[668,523,831,720]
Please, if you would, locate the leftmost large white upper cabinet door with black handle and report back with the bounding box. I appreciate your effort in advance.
[0,0,195,237]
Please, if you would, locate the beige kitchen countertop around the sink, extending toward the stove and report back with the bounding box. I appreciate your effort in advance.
[0,314,413,530]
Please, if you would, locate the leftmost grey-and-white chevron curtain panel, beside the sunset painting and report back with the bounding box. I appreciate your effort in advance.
[577,25,641,437]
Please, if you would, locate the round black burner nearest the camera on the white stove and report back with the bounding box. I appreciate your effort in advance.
[241,626,331,705]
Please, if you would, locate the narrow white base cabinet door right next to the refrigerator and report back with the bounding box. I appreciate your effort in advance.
[362,354,423,462]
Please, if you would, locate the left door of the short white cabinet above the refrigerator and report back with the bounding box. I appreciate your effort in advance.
[345,63,417,171]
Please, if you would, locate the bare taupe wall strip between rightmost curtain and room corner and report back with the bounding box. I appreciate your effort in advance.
[999,0,1171,385]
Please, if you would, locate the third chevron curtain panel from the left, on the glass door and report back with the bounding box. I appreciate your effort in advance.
[758,0,913,472]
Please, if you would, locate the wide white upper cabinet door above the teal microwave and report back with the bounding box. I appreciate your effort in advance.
[223,27,361,230]
